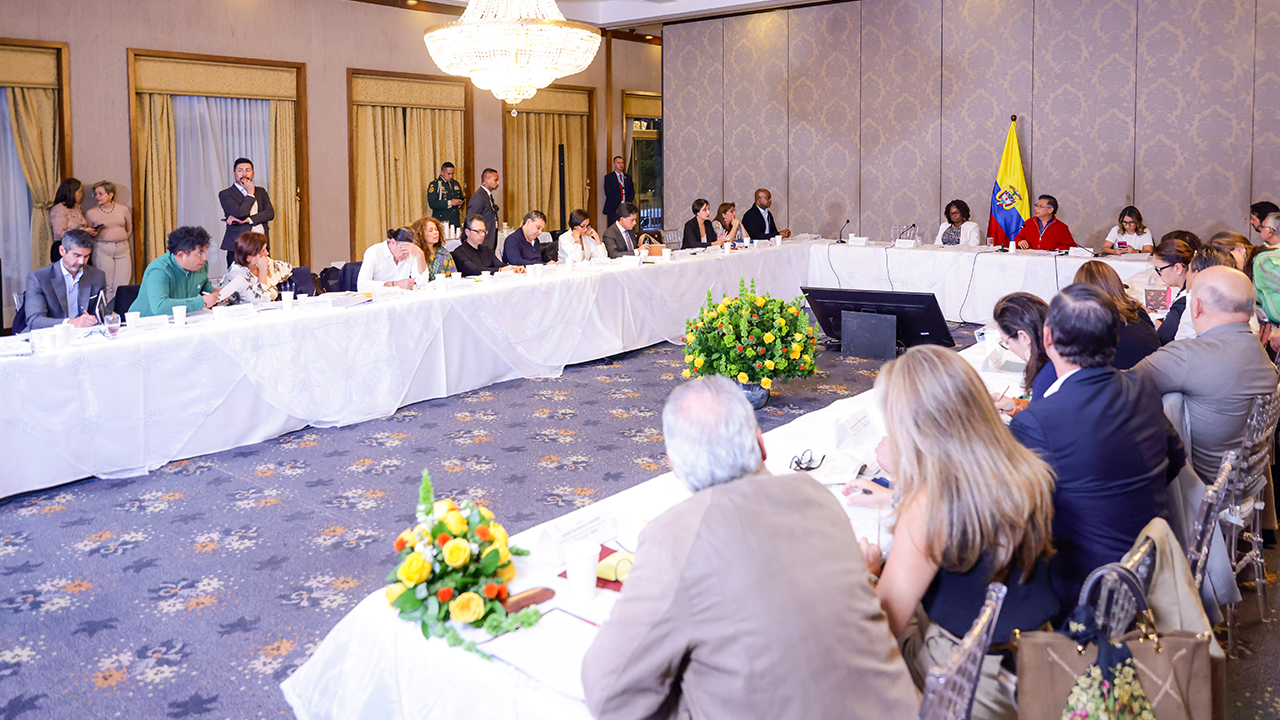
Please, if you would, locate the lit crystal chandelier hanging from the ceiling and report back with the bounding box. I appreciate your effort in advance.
[422,0,600,105]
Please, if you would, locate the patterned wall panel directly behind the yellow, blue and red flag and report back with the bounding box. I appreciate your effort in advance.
[947,0,1034,238]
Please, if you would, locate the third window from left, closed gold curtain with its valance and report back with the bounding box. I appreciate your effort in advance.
[349,73,474,254]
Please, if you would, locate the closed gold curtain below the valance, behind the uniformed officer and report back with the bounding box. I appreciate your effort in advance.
[355,105,466,259]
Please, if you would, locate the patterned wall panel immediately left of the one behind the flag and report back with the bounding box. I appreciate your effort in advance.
[859,0,942,238]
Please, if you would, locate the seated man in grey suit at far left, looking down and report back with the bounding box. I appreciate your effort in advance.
[22,229,106,331]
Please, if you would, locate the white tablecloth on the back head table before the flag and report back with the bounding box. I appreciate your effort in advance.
[809,243,1153,323]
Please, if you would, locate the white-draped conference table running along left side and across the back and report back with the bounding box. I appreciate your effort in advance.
[0,241,1149,497]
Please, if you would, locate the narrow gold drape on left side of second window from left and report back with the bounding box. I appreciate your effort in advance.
[134,92,176,264]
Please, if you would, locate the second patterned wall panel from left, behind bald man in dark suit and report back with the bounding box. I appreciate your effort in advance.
[727,12,788,227]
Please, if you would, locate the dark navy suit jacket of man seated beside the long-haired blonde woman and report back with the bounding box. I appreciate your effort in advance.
[1009,366,1187,614]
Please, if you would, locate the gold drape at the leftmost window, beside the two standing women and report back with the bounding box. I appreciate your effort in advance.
[8,87,61,268]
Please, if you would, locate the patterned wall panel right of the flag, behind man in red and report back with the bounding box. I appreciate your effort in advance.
[1020,0,1147,247]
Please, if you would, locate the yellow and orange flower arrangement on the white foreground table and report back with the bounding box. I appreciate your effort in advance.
[387,470,541,655]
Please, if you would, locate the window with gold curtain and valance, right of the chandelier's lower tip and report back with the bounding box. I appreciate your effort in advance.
[502,87,595,229]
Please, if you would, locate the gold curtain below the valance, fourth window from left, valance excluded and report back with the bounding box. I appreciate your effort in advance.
[503,113,590,228]
